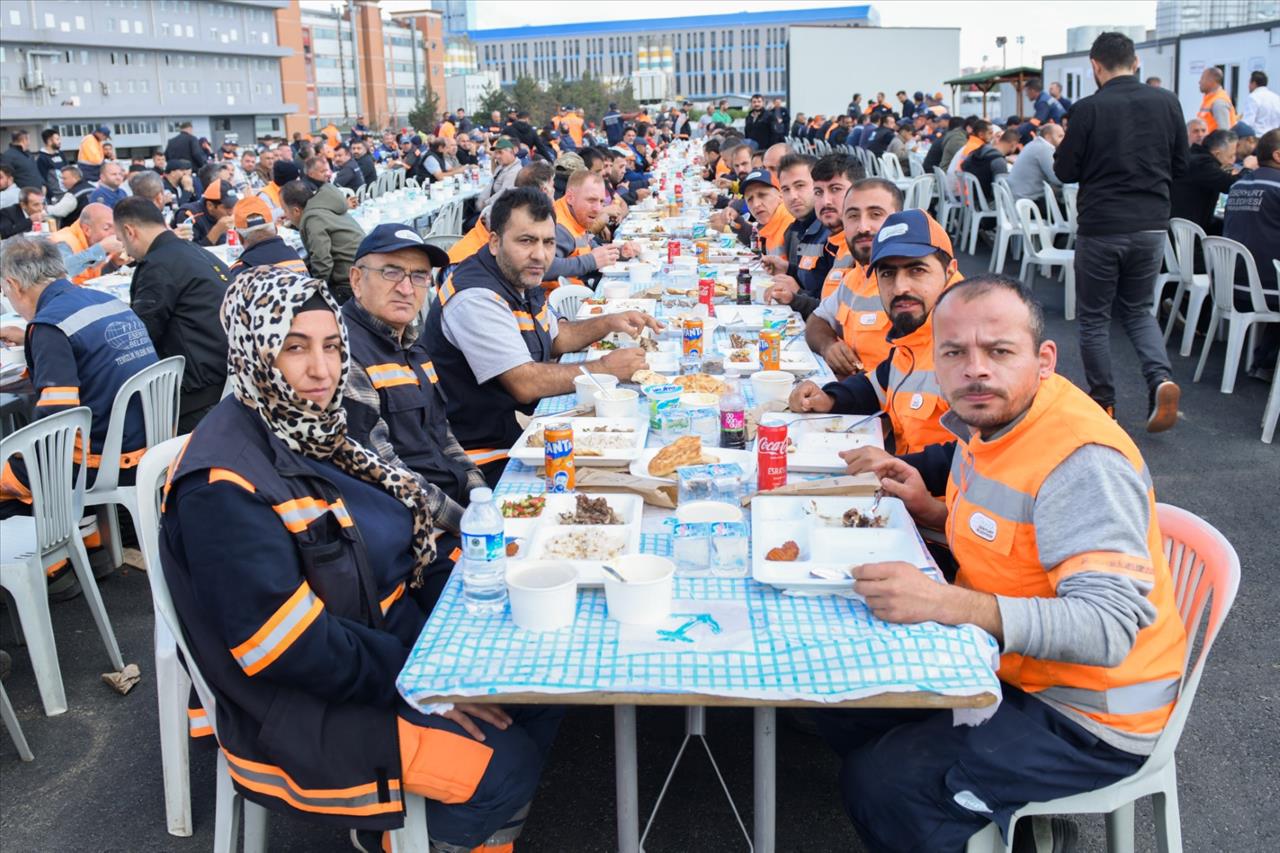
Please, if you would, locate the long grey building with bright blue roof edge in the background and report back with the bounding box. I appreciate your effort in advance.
[463,0,879,100]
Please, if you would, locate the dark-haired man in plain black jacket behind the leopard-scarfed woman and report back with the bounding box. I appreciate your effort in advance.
[114,197,230,434]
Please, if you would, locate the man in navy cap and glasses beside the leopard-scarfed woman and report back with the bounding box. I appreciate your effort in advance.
[342,223,485,602]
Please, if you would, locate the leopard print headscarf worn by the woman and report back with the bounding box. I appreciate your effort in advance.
[221,266,435,587]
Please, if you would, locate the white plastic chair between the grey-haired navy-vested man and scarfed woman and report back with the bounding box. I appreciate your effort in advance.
[84,356,187,566]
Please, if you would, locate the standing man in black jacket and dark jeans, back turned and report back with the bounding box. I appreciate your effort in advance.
[1053,32,1187,433]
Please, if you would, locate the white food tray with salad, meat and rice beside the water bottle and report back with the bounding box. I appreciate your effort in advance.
[498,492,644,587]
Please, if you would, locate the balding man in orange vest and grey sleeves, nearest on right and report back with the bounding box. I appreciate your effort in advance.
[819,274,1185,852]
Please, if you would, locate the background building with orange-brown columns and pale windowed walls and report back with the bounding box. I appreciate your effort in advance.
[301,0,444,127]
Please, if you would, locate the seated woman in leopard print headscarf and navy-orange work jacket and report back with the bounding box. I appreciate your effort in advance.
[161,266,559,852]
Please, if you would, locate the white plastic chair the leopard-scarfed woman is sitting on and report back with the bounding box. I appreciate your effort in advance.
[137,435,430,853]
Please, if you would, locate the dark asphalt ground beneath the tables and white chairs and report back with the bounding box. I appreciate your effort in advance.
[0,242,1280,853]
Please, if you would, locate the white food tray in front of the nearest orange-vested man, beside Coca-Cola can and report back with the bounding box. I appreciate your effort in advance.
[751,496,932,592]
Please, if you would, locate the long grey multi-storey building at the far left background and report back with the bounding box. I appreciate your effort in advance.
[0,0,298,155]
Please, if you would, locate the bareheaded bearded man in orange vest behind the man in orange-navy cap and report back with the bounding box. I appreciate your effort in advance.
[805,178,902,378]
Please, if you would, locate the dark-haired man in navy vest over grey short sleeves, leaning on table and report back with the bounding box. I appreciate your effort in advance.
[425,187,662,485]
